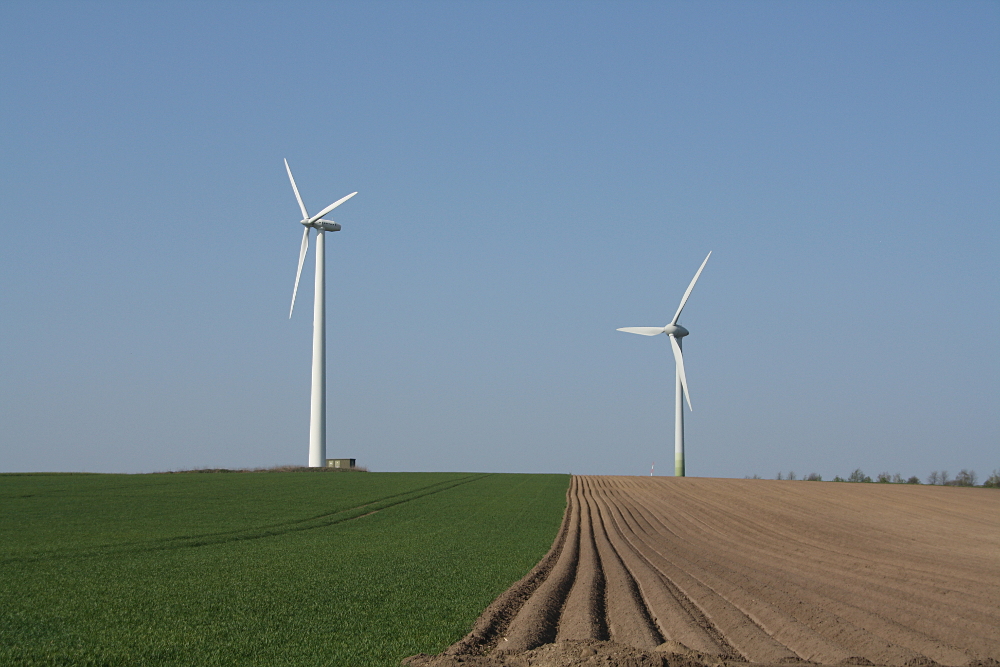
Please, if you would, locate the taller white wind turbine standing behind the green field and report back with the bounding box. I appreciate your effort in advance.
[285,160,358,468]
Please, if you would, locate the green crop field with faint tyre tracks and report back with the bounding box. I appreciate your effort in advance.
[0,472,569,666]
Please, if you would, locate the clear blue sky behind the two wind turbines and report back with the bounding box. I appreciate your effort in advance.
[0,2,1000,478]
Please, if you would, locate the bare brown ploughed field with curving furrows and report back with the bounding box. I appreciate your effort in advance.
[405,477,1000,667]
